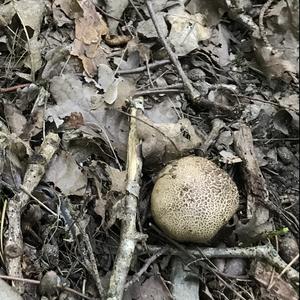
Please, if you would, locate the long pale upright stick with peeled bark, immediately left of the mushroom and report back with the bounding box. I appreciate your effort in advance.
[107,99,144,300]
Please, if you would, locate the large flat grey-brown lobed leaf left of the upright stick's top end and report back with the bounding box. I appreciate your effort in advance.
[46,75,128,160]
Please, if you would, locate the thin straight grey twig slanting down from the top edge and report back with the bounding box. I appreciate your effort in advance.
[146,0,200,104]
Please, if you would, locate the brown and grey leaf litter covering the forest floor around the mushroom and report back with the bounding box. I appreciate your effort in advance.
[0,0,299,300]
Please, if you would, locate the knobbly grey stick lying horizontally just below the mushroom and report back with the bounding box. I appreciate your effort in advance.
[142,244,299,283]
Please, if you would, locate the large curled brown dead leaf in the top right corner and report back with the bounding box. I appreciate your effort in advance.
[254,0,299,82]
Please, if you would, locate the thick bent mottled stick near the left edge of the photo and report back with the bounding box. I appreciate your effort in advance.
[4,133,60,292]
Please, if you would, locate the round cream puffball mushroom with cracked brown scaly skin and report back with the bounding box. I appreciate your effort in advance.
[151,156,239,243]
